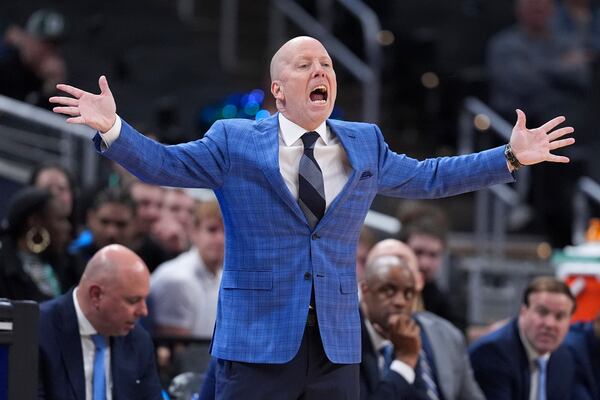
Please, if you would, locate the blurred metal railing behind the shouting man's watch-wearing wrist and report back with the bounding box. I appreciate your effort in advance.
[458,97,530,259]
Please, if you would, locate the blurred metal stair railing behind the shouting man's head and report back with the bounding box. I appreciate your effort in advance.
[219,0,381,123]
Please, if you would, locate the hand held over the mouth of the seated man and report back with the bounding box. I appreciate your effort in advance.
[387,314,421,368]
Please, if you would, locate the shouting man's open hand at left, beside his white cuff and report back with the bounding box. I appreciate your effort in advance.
[50,75,117,132]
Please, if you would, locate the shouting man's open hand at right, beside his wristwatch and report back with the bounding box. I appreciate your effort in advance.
[510,110,575,165]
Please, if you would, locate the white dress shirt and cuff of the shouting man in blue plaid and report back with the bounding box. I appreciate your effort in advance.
[101,113,352,208]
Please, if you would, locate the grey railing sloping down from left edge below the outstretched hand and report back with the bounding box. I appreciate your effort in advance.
[0,95,99,187]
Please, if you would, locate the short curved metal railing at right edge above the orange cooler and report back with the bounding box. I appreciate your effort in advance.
[571,176,600,245]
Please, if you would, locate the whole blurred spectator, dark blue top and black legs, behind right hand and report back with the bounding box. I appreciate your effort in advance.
[487,0,595,247]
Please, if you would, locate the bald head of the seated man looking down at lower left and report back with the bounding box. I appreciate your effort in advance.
[77,244,150,336]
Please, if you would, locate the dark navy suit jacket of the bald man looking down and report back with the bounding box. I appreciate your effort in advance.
[38,290,162,400]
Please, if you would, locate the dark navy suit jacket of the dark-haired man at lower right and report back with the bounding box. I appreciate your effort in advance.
[469,319,574,400]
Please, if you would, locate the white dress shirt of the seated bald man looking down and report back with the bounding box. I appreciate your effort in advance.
[73,288,112,400]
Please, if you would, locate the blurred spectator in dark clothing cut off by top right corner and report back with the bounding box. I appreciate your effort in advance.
[553,0,600,56]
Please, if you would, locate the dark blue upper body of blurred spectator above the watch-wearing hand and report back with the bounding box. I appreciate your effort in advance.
[487,0,590,126]
